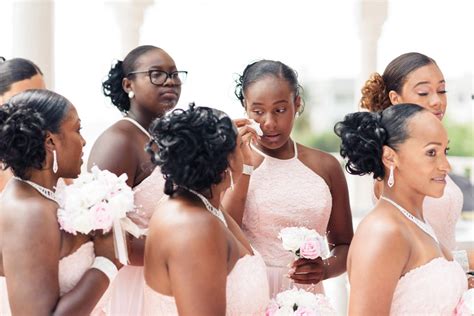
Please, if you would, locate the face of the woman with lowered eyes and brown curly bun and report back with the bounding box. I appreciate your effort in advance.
[390,63,447,120]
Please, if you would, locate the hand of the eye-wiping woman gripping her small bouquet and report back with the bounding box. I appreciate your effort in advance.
[289,257,325,284]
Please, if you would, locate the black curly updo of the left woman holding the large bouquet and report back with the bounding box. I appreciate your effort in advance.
[0,90,70,179]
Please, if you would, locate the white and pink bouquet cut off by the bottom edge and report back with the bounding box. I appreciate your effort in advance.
[265,287,336,316]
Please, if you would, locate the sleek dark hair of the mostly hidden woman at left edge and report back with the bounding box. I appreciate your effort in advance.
[0,57,43,95]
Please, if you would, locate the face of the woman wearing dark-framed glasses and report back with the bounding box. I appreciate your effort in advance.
[123,49,181,117]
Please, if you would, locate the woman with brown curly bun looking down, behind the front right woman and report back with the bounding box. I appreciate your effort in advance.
[360,53,474,270]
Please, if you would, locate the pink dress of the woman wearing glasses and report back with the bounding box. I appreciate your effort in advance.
[105,168,165,316]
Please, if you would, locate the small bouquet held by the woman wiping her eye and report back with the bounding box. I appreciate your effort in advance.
[278,227,328,259]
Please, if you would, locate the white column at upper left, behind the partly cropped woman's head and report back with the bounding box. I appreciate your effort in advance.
[12,0,54,90]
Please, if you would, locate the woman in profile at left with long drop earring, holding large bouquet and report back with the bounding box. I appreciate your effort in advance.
[0,90,117,315]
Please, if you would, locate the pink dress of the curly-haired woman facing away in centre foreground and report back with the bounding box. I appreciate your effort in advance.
[145,252,269,316]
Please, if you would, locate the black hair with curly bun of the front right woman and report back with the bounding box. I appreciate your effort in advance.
[334,103,425,180]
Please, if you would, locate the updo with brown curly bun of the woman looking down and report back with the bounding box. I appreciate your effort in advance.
[360,53,436,112]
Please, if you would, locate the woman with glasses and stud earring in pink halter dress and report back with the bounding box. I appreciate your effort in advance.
[88,45,187,315]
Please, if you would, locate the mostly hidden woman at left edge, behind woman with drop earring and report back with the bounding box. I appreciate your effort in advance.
[0,57,45,192]
